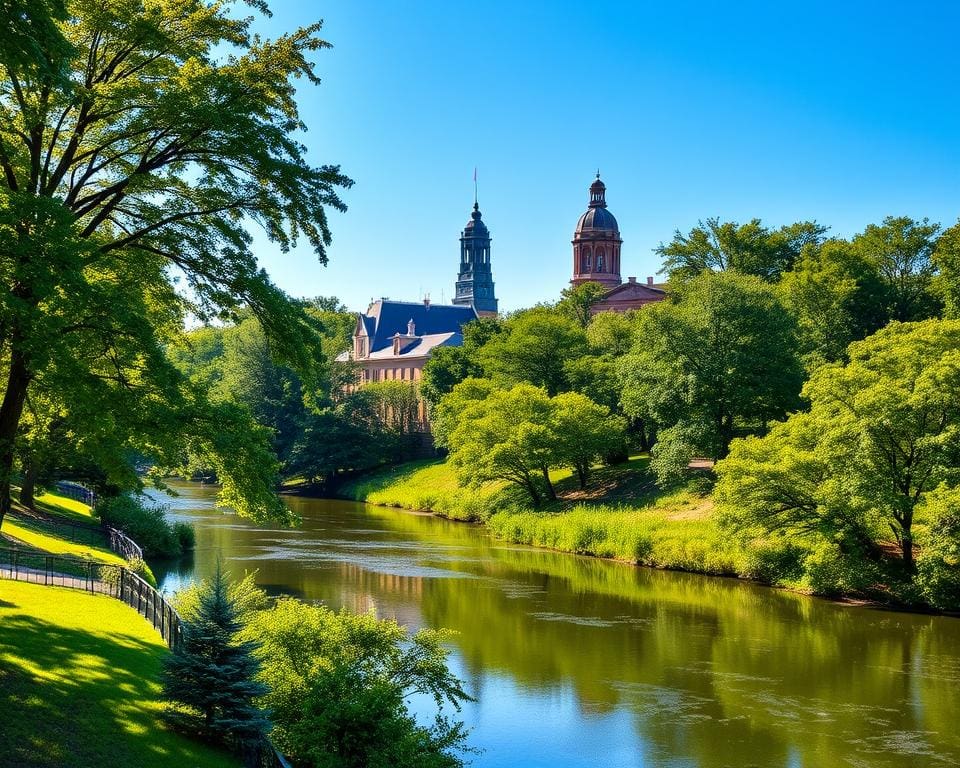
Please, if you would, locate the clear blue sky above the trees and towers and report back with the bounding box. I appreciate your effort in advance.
[249,0,960,310]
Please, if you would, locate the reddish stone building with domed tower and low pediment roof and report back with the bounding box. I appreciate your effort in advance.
[570,173,667,314]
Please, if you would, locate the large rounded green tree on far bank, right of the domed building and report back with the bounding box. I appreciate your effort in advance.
[620,272,803,480]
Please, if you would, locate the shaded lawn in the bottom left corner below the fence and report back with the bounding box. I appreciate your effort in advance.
[0,581,238,768]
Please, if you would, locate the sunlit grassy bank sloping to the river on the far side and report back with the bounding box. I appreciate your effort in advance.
[341,457,747,574]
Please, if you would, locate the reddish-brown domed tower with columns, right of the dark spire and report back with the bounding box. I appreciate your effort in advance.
[570,171,623,288]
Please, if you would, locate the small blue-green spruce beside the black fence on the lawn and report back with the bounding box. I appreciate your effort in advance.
[163,563,269,754]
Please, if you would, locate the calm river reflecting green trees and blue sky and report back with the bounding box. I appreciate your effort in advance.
[146,484,960,768]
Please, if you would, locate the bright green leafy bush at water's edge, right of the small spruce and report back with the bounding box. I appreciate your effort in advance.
[243,599,469,768]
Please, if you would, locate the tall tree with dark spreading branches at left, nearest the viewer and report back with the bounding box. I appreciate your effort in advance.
[0,0,350,517]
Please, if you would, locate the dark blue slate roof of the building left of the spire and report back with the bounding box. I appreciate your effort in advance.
[358,299,477,356]
